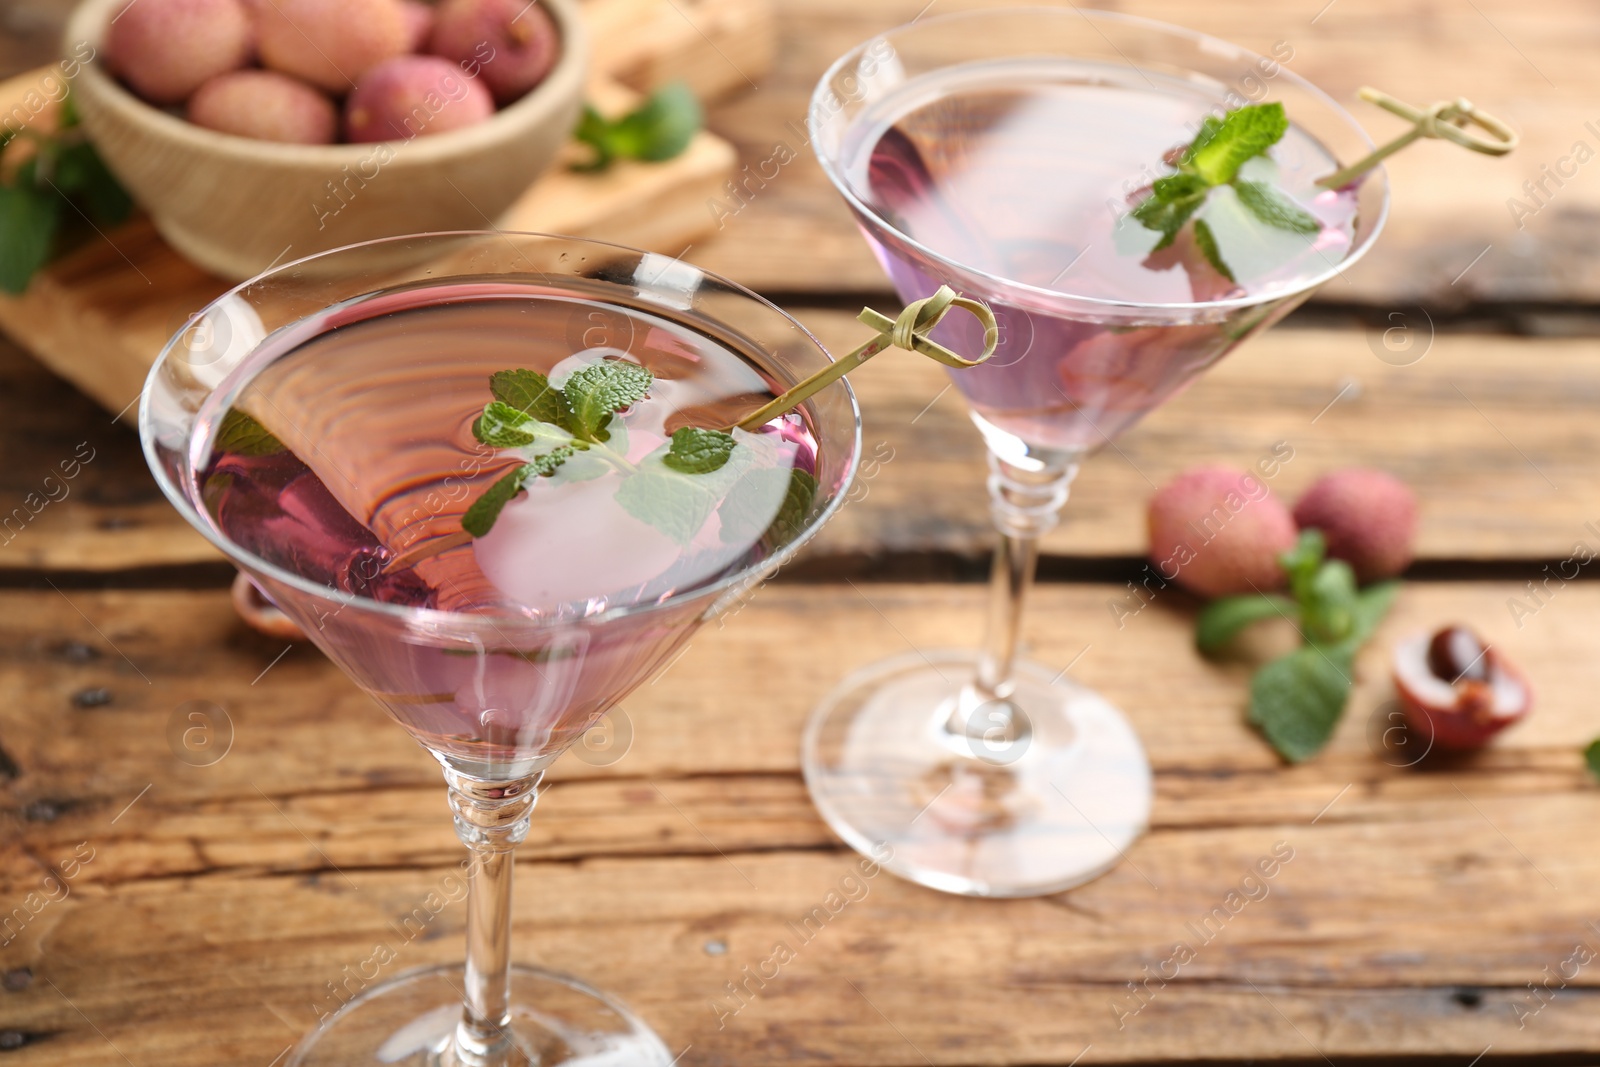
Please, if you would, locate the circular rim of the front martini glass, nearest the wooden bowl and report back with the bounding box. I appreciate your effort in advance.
[139,230,861,641]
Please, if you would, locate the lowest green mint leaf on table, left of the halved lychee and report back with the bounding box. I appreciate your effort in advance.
[1250,645,1352,763]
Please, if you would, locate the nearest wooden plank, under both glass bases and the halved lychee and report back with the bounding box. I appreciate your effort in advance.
[0,584,1600,1067]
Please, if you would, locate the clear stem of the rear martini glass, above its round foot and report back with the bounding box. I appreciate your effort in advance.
[947,453,1078,744]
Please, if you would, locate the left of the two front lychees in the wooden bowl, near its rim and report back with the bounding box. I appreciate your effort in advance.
[189,70,339,144]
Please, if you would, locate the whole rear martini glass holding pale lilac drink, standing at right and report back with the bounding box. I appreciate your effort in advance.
[803,6,1387,896]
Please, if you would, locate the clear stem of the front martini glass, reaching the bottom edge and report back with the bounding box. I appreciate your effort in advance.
[445,766,542,1067]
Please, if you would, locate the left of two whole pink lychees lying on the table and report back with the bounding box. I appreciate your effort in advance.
[1149,466,1296,597]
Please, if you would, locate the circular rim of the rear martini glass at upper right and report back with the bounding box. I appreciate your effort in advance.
[806,5,1390,312]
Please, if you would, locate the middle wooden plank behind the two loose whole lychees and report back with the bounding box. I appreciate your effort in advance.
[0,321,1600,577]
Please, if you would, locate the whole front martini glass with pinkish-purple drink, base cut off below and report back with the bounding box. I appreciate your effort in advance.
[139,232,859,1067]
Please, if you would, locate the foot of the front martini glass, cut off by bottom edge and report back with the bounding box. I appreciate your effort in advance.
[288,965,672,1067]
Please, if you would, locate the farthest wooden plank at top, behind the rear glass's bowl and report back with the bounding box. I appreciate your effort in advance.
[684,0,1600,309]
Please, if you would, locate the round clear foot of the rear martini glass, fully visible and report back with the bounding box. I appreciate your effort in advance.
[803,651,1150,897]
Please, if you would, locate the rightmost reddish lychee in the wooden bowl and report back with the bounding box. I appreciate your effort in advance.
[427,0,560,104]
